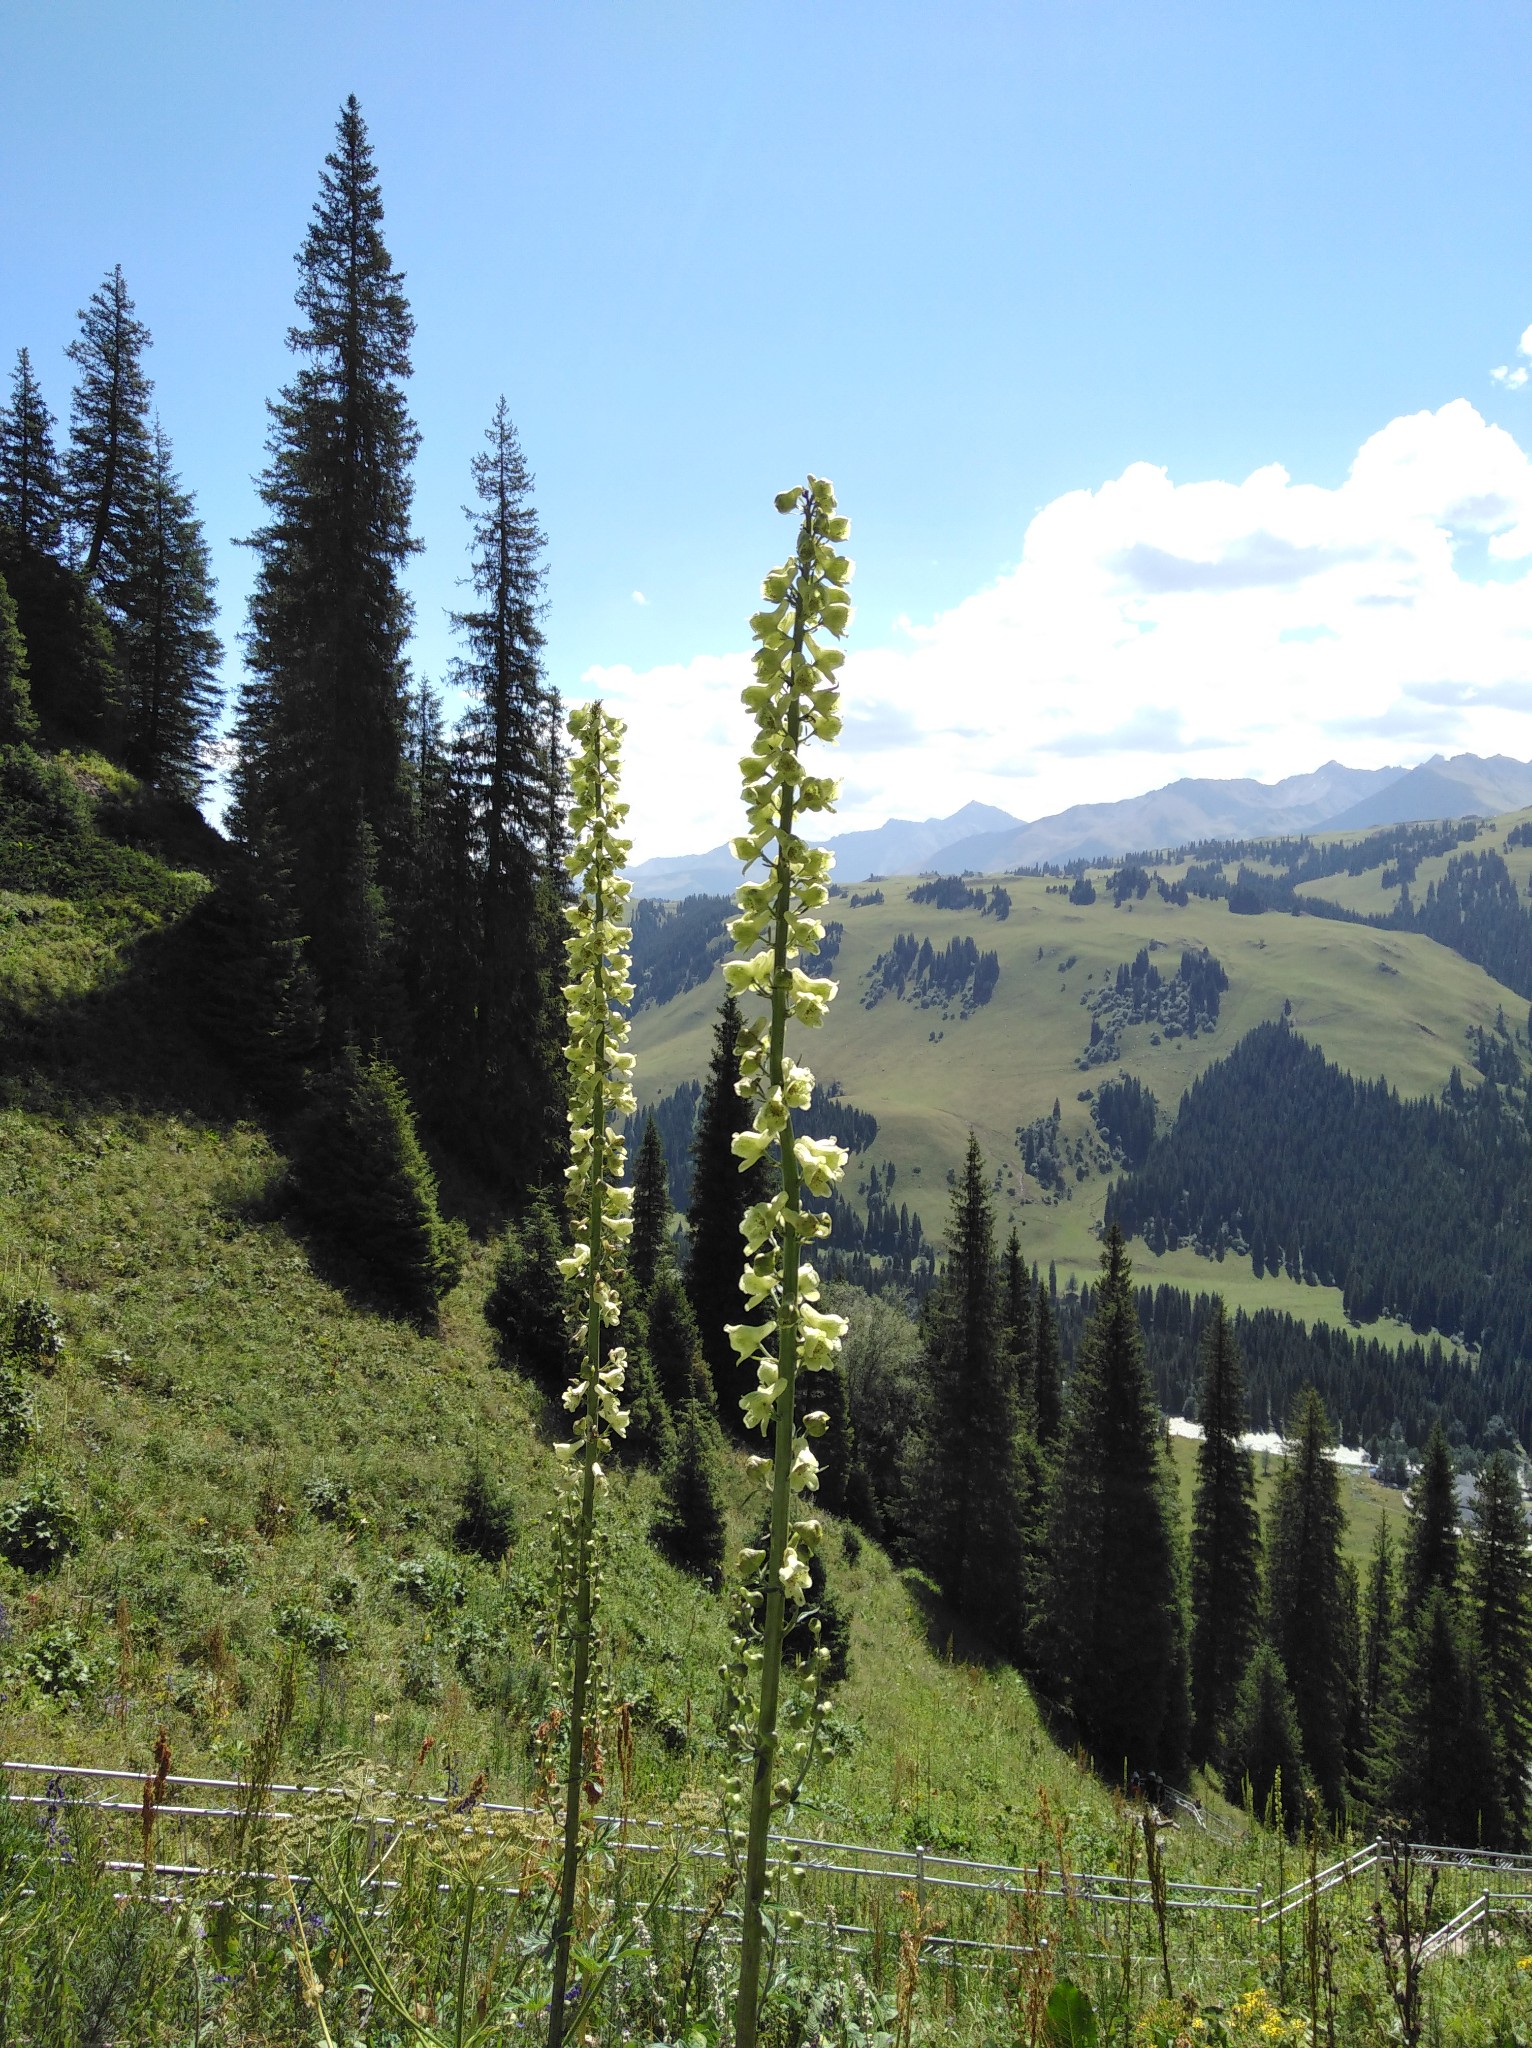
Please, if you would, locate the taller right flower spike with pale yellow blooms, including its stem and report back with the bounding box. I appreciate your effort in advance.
[723,477,852,2048]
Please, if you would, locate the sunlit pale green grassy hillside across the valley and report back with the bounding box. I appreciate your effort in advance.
[633,821,1532,1333]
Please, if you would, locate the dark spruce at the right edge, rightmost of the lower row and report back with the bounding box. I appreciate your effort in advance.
[1469,1450,1532,1845]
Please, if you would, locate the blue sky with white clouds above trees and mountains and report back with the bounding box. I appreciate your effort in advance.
[0,0,1532,852]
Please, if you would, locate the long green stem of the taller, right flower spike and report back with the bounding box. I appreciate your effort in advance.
[735,598,803,2048]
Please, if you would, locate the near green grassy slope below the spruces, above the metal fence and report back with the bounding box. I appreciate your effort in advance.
[0,770,1108,1855]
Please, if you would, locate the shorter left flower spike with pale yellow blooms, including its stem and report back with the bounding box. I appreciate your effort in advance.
[549,702,633,2048]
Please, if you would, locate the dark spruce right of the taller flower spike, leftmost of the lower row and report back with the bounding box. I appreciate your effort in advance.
[913,1133,1024,1655]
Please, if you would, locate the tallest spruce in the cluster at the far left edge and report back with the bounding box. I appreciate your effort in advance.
[66,264,154,585]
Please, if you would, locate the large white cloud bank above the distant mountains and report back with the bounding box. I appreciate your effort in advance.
[586,403,1532,858]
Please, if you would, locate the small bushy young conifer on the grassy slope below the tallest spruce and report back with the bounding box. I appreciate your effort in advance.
[295,1047,465,1321]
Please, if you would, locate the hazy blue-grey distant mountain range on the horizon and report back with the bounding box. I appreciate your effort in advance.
[629,754,1532,899]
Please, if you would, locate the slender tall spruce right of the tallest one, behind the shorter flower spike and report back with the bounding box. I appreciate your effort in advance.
[438,397,563,1182]
